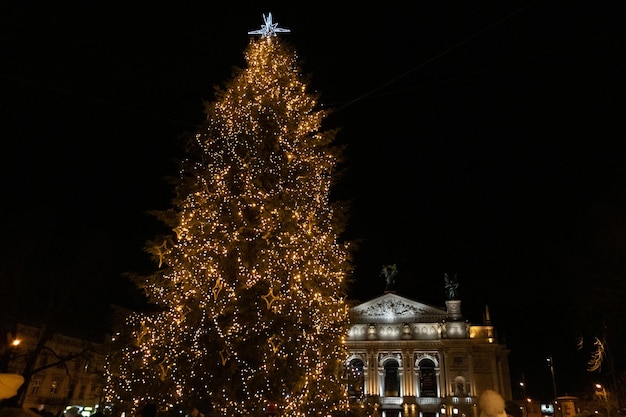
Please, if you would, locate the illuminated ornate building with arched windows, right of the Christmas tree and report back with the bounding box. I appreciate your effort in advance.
[346,291,512,417]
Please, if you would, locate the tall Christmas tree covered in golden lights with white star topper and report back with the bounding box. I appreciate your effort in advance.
[107,15,351,416]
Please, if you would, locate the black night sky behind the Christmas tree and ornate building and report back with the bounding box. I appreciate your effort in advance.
[0,0,626,395]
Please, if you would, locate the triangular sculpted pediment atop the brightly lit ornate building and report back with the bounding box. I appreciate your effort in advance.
[350,293,447,323]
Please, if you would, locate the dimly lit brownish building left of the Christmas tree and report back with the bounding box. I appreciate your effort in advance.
[9,324,105,416]
